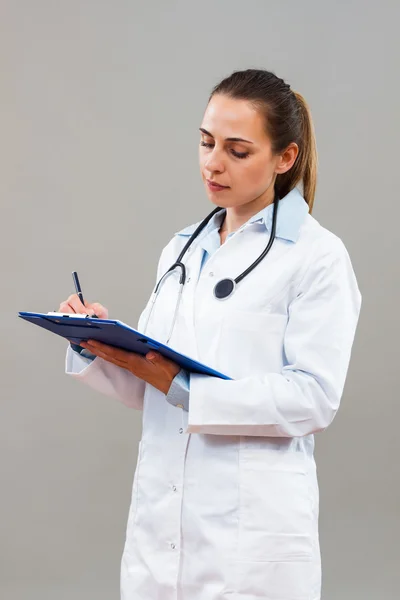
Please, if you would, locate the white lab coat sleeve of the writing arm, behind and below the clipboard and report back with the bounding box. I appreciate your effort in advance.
[65,243,166,410]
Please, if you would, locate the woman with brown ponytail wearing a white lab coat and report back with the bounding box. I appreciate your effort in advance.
[59,69,361,600]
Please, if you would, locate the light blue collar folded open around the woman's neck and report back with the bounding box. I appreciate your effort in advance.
[175,188,308,242]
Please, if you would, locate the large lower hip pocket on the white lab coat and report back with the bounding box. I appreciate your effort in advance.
[238,451,314,562]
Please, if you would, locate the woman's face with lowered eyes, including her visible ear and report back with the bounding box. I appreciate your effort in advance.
[199,94,298,210]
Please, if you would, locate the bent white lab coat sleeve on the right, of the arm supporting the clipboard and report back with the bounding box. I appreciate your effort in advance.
[187,238,361,437]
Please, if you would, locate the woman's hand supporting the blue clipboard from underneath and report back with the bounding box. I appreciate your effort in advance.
[79,340,181,394]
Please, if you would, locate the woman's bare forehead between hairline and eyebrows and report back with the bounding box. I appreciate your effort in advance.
[201,94,267,143]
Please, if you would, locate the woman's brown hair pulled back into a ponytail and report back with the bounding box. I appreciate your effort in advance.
[208,69,318,213]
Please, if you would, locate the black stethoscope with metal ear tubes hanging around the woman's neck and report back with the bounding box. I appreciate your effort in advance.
[143,185,280,344]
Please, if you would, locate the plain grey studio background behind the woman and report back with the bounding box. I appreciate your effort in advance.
[0,0,400,600]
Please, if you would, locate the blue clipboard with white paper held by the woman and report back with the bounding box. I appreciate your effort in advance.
[18,312,232,379]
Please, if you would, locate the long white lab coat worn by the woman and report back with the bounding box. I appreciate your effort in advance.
[66,193,361,600]
